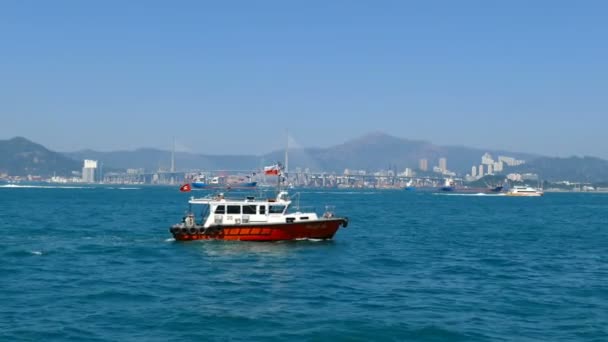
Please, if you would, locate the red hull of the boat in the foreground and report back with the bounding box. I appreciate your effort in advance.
[170,218,348,241]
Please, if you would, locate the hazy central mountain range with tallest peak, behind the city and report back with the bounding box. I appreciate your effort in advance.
[66,132,536,173]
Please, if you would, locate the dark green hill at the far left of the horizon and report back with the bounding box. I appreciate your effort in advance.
[0,137,82,176]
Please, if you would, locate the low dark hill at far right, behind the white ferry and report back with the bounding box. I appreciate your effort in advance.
[514,157,608,183]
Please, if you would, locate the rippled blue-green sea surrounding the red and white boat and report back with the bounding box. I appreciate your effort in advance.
[0,185,608,342]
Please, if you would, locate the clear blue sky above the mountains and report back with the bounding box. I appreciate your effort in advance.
[0,0,608,158]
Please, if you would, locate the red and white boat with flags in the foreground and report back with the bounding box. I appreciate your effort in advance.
[170,164,348,241]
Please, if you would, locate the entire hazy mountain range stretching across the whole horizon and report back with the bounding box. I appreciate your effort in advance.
[0,133,608,182]
